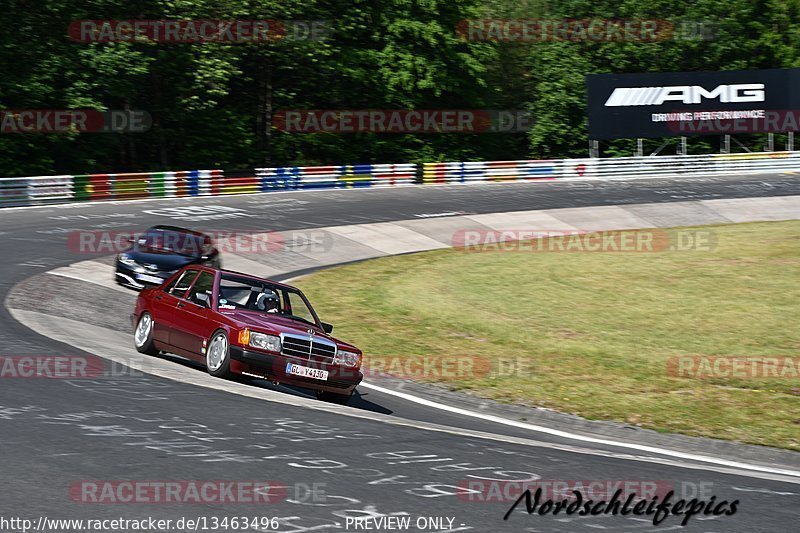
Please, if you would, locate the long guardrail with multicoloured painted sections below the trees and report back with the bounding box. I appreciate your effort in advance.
[0,152,800,207]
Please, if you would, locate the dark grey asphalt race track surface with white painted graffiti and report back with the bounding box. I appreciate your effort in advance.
[0,175,800,533]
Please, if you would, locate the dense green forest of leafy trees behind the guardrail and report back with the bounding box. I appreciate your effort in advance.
[0,0,800,176]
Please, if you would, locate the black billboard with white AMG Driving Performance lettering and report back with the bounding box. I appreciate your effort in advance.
[586,69,800,140]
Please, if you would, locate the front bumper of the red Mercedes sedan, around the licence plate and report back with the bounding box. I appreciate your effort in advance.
[230,346,364,394]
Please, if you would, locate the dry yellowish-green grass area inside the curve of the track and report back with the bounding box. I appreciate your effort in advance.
[297,222,800,450]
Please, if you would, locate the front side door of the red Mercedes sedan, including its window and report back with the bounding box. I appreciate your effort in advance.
[172,270,215,358]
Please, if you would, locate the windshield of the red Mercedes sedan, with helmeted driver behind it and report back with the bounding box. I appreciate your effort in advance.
[218,274,319,326]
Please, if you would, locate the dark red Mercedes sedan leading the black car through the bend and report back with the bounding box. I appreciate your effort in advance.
[131,265,363,404]
